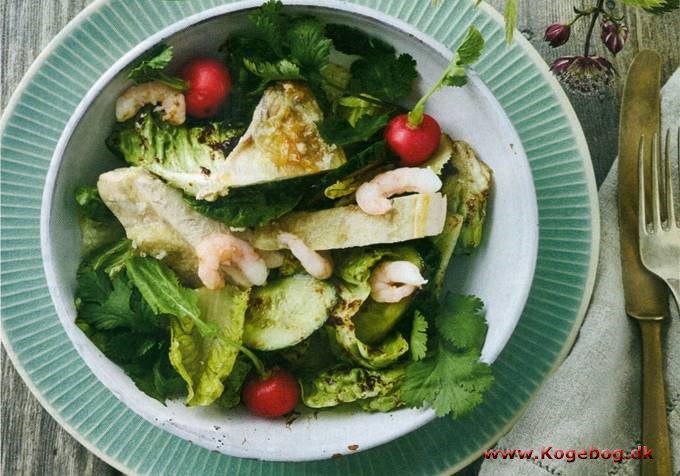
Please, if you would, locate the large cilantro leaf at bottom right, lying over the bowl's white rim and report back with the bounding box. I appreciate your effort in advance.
[401,344,493,418]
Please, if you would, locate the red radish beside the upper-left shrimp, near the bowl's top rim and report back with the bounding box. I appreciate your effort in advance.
[181,58,231,119]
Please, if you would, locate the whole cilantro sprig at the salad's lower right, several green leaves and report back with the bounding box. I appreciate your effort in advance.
[401,295,493,418]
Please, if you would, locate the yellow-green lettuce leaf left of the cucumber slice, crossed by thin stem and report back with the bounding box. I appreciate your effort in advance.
[169,286,249,406]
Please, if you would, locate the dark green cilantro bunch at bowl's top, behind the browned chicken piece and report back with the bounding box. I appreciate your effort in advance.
[222,0,418,122]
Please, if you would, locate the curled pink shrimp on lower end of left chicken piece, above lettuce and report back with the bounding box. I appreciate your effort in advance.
[196,233,269,289]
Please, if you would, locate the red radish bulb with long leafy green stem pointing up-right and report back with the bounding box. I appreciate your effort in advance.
[385,114,442,167]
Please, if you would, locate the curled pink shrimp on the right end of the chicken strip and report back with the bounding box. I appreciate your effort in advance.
[356,167,442,215]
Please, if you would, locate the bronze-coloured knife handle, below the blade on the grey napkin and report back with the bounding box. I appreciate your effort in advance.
[639,321,672,476]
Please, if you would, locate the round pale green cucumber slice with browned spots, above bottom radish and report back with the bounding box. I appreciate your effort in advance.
[243,274,338,350]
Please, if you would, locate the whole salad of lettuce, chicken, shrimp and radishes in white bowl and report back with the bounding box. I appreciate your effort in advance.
[75,1,493,424]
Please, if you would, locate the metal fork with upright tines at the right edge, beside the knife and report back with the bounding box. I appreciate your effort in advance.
[638,129,680,310]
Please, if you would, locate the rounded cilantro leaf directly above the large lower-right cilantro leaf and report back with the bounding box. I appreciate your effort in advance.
[435,294,487,351]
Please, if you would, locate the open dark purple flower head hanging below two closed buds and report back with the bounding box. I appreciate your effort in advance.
[550,56,616,95]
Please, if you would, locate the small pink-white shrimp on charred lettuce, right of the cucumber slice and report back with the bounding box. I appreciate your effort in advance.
[369,261,427,302]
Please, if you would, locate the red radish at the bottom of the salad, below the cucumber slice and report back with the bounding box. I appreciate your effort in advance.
[243,369,300,418]
